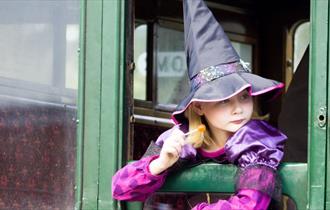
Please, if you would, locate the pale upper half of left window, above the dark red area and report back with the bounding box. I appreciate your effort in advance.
[0,0,79,105]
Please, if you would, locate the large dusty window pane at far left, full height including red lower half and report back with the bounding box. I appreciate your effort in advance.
[0,0,80,210]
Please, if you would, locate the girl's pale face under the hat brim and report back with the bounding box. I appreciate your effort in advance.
[194,90,253,133]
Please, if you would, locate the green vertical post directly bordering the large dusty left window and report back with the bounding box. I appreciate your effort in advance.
[76,0,103,210]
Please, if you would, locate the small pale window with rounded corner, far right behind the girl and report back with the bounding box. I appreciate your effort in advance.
[293,22,310,73]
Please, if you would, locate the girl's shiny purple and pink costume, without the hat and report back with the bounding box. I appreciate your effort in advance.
[112,120,286,210]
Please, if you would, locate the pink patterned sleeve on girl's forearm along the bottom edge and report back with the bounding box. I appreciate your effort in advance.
[192,190,271,210]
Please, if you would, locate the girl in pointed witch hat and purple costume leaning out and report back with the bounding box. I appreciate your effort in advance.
[112,0,286,210]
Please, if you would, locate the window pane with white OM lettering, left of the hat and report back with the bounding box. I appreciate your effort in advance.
[156,27,189,105]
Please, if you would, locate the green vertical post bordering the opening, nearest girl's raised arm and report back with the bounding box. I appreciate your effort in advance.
[98,0,126,210]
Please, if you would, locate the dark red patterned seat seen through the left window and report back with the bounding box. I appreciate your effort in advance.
[0,95,76,209]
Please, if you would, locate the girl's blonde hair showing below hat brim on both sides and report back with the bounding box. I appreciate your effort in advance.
[184,99,269,148]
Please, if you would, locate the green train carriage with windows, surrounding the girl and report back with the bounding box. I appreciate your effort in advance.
[0,0,330,210]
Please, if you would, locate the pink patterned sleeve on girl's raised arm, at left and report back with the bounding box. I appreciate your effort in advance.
[112,156,167,201]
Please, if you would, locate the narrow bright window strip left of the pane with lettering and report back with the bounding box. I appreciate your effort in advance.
[133,24,147,100]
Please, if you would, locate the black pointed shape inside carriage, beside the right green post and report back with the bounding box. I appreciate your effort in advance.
[278,47,309,163]
